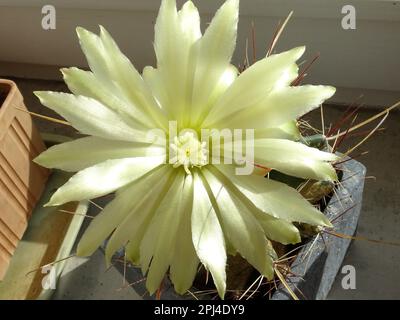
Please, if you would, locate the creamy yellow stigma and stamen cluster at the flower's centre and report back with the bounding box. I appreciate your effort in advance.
[170,132,208,174]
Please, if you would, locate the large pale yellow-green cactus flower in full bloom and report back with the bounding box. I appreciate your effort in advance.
[35,0,337,297]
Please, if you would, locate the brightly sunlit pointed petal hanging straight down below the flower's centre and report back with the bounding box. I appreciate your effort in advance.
[192,172,226,298]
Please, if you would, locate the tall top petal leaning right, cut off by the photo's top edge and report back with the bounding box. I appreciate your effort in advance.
[191,0,239,125]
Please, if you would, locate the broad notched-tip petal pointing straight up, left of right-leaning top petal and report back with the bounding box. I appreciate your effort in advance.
[151,0,201,123]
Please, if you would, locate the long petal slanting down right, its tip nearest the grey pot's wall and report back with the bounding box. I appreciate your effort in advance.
[215,165,332,227]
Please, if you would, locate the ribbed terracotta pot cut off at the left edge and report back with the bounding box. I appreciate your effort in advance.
[0,79,49,280]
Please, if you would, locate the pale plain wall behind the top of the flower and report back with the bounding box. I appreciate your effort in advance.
[0,0,400,106]
